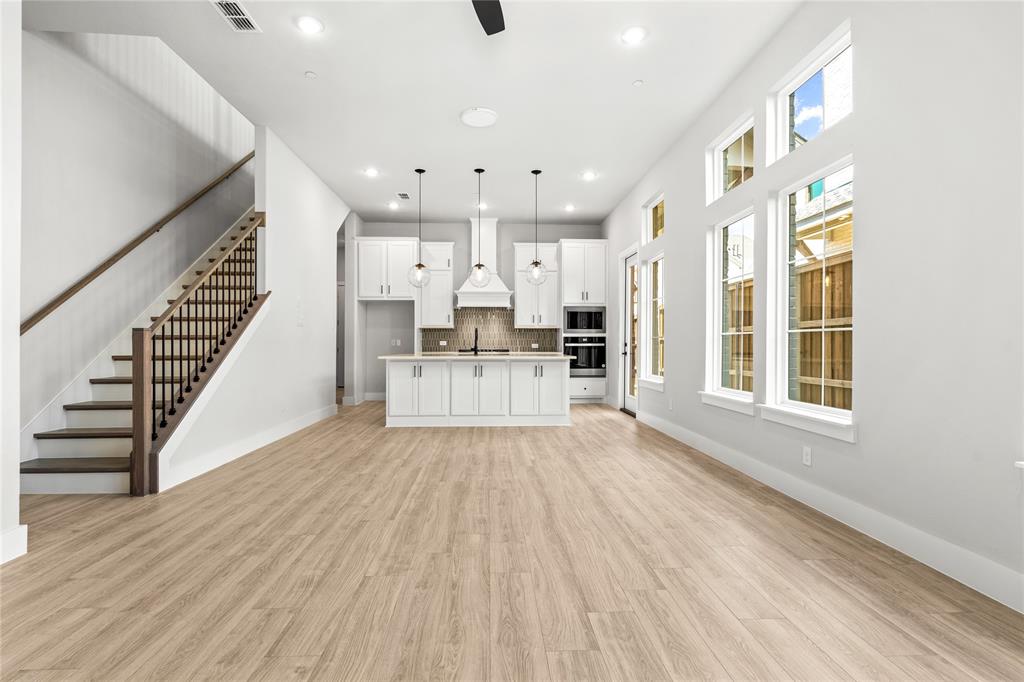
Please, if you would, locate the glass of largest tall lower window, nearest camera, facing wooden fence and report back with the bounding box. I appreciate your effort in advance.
[786,166,853,410]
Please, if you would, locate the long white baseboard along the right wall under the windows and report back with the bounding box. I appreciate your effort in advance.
[637,413,1024,612]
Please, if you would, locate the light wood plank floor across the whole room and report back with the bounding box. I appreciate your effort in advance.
[0,403,1024,681]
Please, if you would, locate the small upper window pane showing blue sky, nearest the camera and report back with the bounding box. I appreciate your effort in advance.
[787,44,853,151]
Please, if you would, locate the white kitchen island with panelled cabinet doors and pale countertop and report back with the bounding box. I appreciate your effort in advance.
[380,351,572,426]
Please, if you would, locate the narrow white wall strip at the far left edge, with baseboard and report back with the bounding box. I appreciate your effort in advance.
[0,0,28,562]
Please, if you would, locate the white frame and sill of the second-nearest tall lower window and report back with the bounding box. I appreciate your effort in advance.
[700,205,761,415]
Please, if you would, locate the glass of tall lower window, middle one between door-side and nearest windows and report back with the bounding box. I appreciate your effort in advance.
[714,214,754,392]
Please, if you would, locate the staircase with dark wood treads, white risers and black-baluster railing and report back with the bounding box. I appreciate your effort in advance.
[20,206,269,495]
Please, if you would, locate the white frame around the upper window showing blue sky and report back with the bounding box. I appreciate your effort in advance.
[765,19,856,166]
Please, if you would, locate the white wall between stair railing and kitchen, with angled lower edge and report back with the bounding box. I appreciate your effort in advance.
[154,127,348,489]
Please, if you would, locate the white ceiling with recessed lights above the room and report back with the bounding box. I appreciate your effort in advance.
[25,0,797,222]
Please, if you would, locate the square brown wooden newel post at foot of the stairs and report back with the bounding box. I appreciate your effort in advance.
[128,328,157,496]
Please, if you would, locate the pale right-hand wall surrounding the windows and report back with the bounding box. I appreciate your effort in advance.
[604,2,1024,609]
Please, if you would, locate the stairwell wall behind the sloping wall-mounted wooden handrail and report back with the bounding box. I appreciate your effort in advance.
[20,32,253,426]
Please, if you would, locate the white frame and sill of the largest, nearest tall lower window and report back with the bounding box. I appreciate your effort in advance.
[761,155,857,428]
